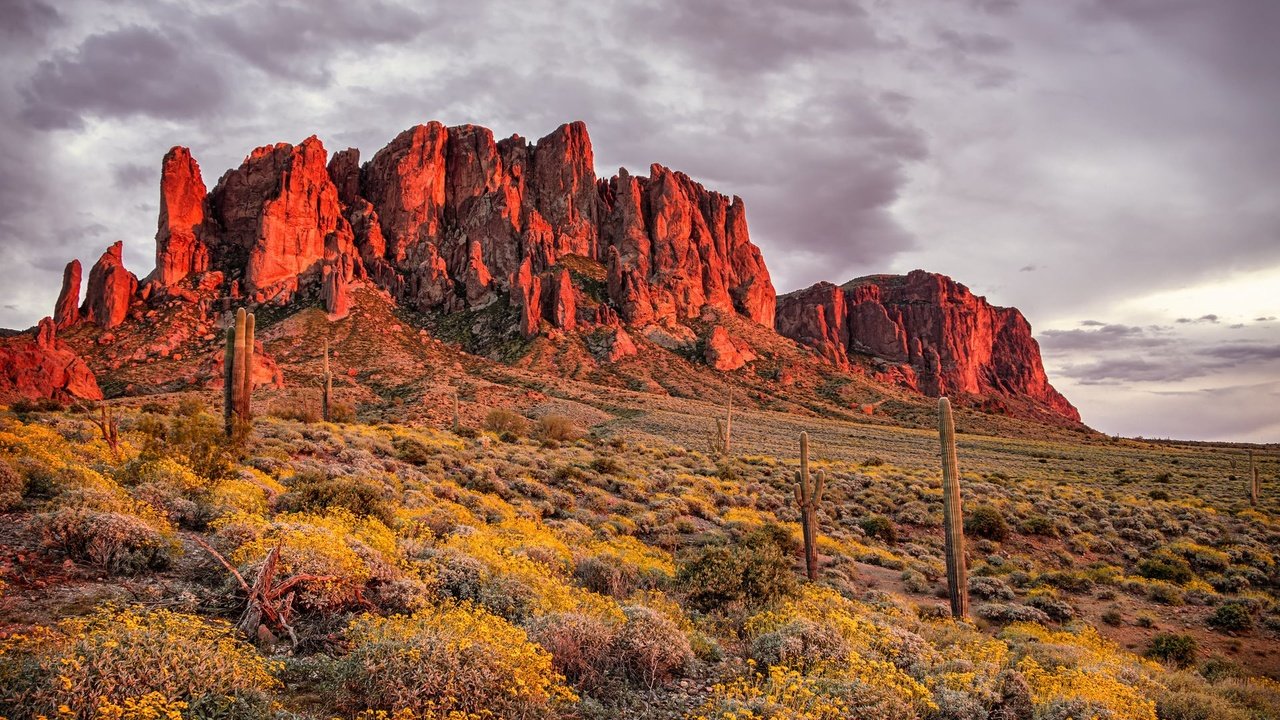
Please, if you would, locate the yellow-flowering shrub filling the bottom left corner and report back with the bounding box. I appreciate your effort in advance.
[0,606,279,720]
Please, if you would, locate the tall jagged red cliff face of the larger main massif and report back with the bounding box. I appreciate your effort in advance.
[117,123,776,336]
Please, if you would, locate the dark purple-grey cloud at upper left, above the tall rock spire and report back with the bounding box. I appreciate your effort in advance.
[22,26,228,129]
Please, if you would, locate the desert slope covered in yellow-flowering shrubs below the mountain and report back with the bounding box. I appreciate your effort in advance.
[0,393,1280,720]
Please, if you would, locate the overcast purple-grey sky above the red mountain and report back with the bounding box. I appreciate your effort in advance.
[0,0,1280,442]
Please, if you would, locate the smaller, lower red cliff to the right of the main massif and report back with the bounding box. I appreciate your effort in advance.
[777,270,1080,421]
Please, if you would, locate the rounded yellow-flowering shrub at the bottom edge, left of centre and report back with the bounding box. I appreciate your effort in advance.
[338,603,577,719]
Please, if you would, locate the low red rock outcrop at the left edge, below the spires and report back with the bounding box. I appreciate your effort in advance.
[0,318,102,402]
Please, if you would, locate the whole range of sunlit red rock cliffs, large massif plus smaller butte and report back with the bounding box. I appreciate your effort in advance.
[17,122,1078,420]
